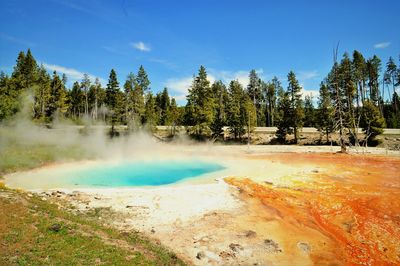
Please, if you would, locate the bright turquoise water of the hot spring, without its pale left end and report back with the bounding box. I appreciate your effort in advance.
[69,160,224,187]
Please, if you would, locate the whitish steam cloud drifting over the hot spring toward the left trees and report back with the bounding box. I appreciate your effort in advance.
[0,95,228,173]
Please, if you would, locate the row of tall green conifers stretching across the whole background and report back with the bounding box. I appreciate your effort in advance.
[0,49,400,145]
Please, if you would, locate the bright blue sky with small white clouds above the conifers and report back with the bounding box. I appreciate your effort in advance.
[0,0,400,104]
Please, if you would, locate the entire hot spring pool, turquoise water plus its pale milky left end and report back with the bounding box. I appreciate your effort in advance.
[7,160,225,189]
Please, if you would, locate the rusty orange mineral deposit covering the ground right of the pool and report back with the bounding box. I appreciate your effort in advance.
[226,153,400,265]
